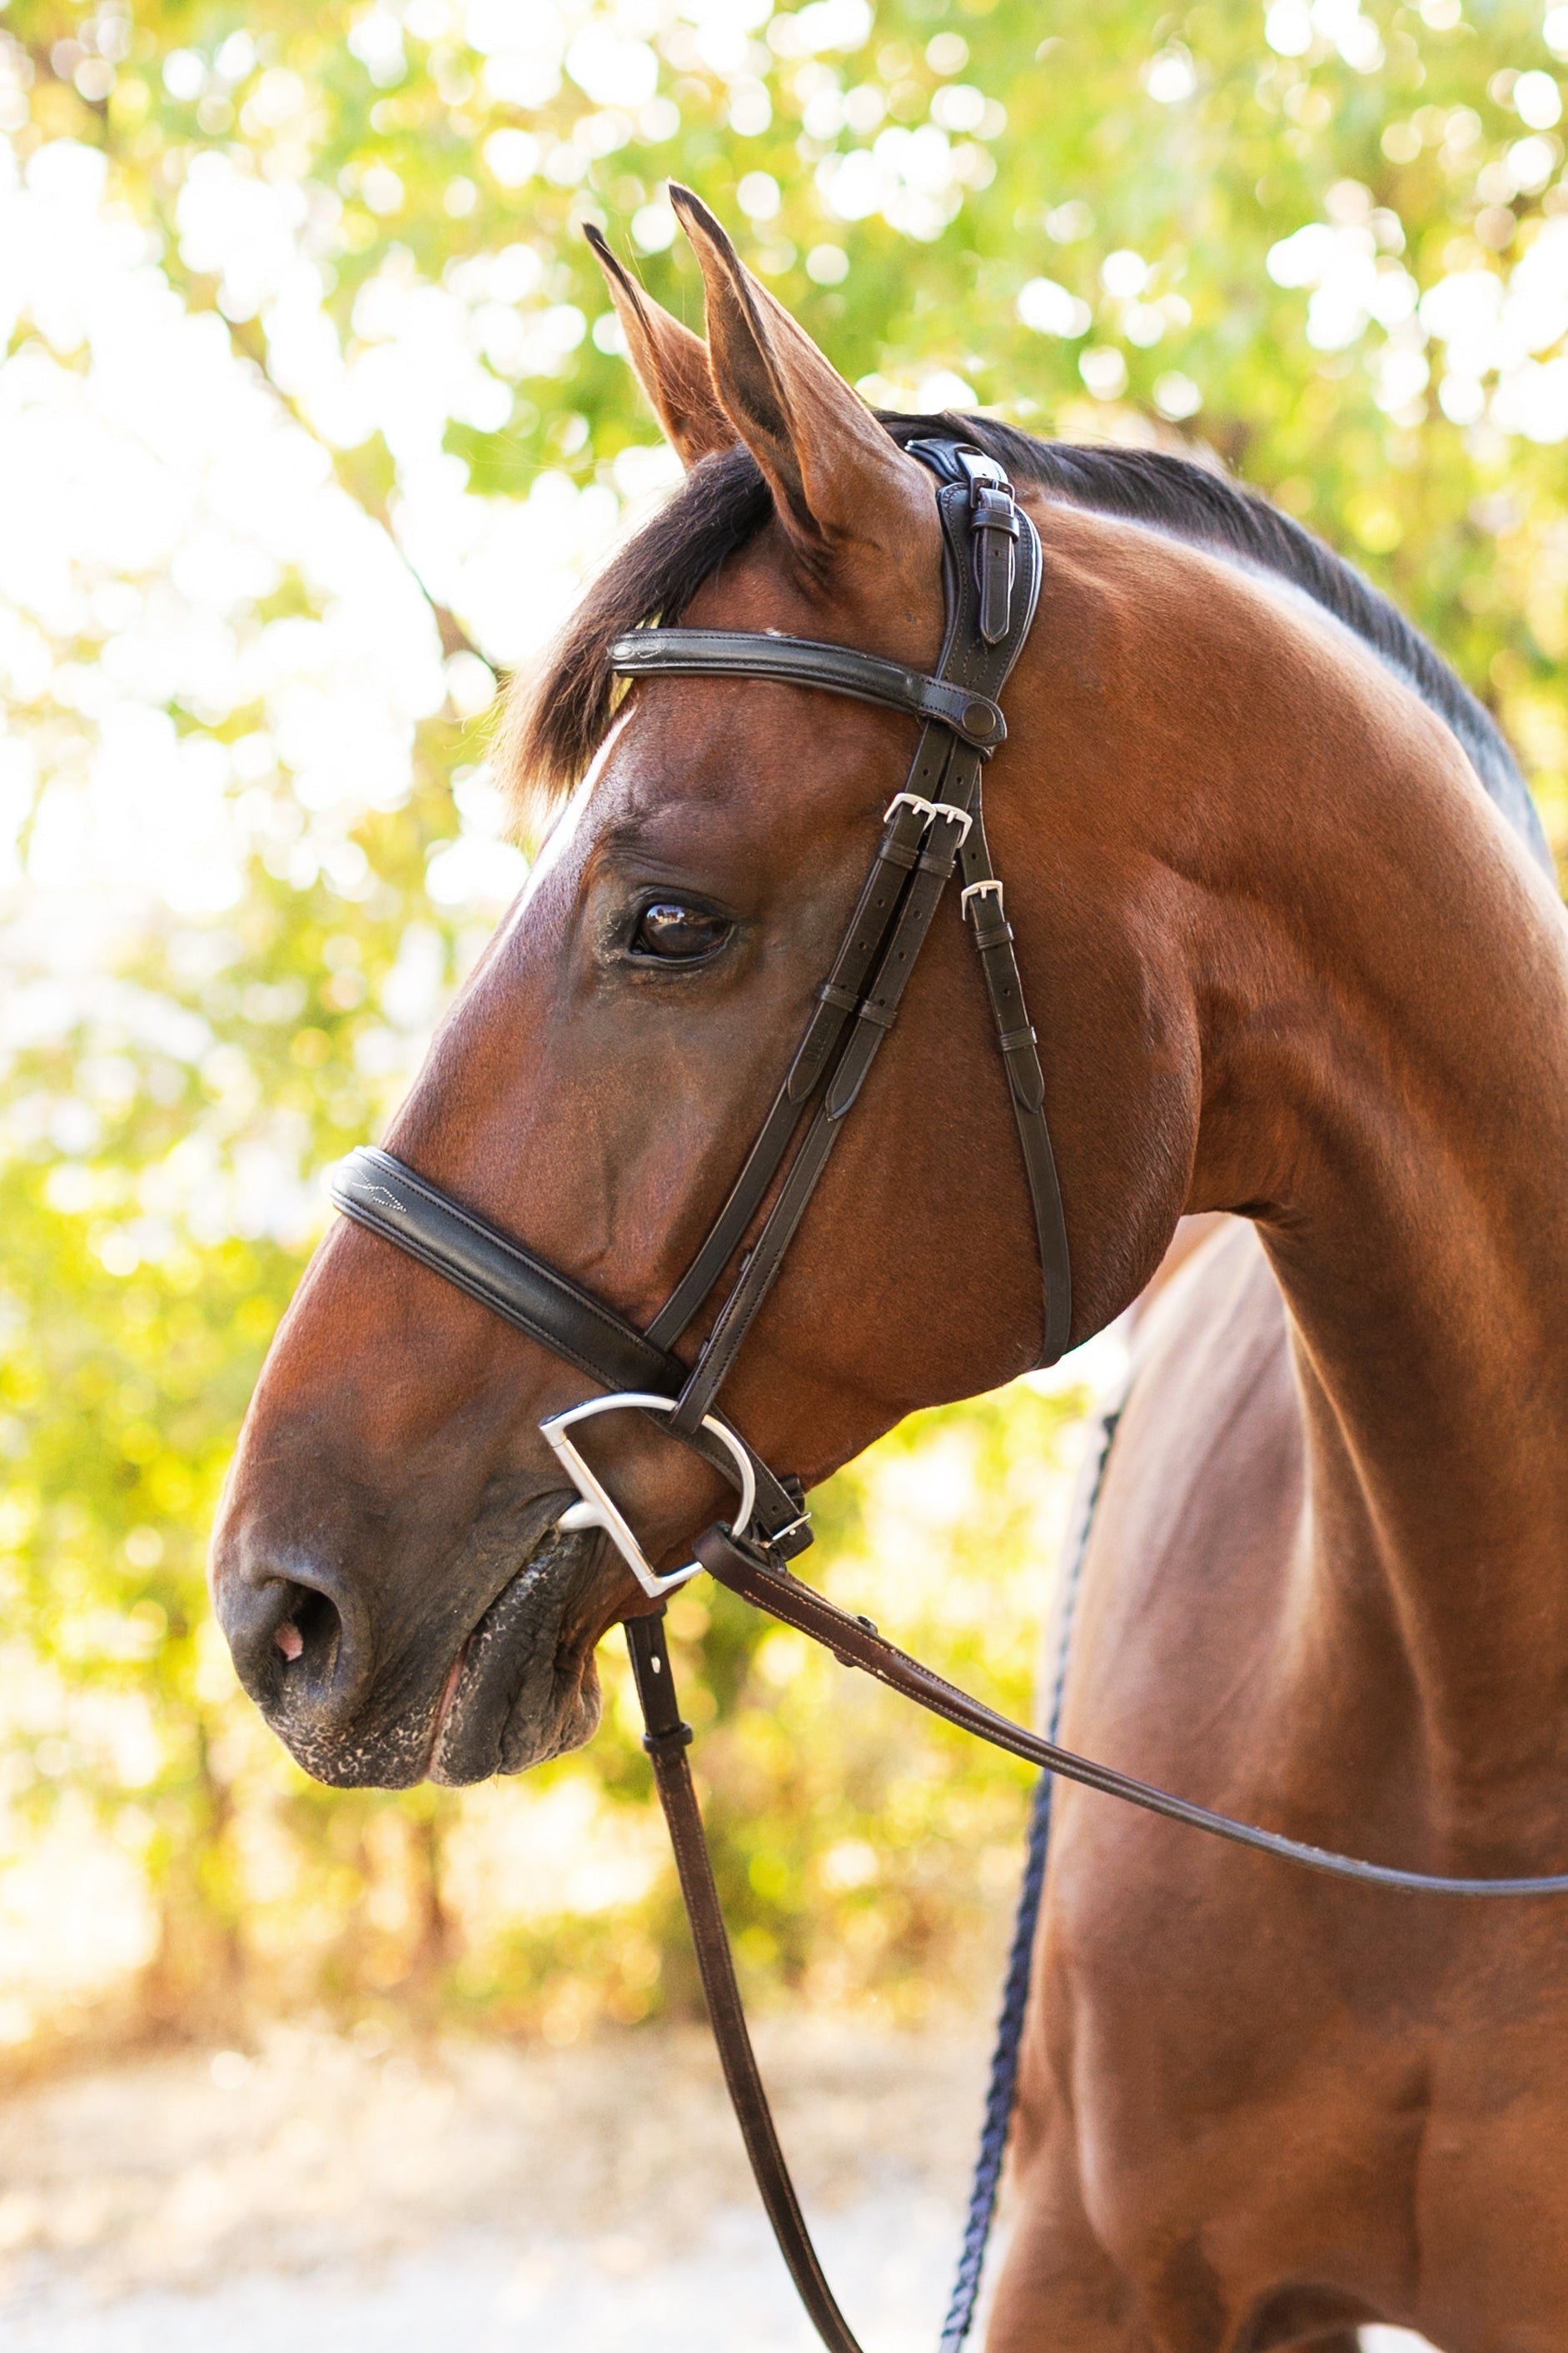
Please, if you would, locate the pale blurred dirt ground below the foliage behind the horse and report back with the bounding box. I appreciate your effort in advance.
[0,2021,1420,2353]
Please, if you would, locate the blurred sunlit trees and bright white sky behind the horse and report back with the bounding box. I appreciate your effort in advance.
[0,0,1568,2117]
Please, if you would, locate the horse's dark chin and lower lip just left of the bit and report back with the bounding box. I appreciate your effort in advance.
[428,1527,605,1788]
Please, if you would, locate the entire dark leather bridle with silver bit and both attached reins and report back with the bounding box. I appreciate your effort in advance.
[331,440,1568,2353]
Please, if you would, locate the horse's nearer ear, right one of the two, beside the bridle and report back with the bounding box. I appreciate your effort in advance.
[670,183,936,562]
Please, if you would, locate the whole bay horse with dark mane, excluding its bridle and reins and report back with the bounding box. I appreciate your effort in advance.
[212,195,1568,2353]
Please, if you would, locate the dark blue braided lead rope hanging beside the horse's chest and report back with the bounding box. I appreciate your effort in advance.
[940,1398,1122,2353]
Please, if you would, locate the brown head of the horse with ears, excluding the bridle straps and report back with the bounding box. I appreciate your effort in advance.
[212,193,1199,1786]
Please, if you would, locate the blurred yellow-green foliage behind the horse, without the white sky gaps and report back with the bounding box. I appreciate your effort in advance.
[0,0,1568,2036]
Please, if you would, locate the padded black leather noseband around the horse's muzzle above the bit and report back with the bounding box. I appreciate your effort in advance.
[331,1144,811,1555]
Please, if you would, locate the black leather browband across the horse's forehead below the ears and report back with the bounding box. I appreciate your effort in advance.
[609,628,1006,760]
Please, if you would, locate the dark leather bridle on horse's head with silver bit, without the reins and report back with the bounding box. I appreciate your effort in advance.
[334,442,1072,1600]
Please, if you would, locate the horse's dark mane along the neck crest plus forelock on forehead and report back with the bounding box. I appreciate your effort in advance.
[500,410,1551,868]
